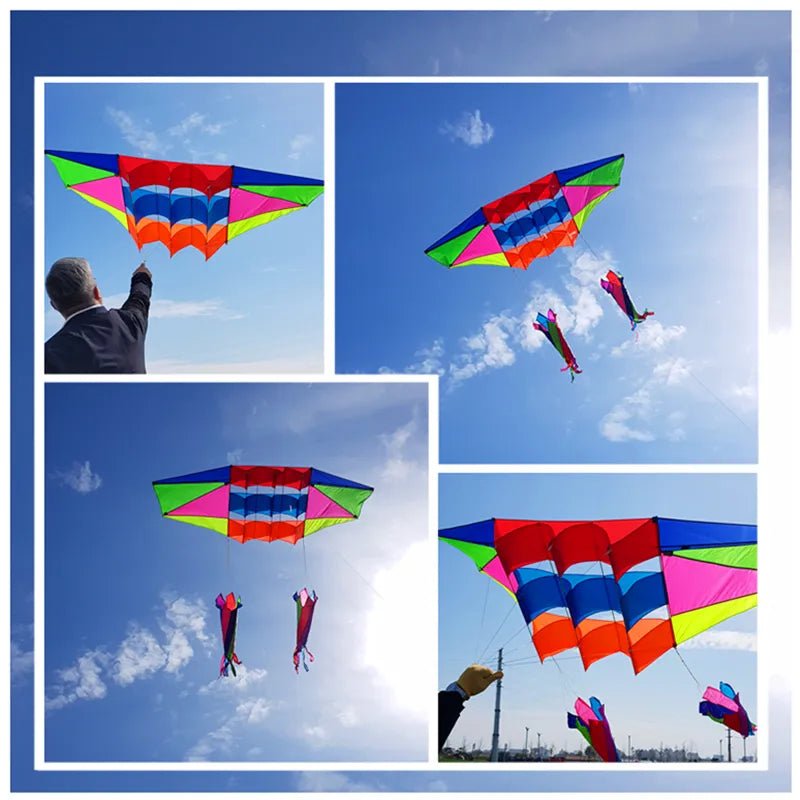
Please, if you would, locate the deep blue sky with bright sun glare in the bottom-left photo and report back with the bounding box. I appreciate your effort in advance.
[45,384,434,761]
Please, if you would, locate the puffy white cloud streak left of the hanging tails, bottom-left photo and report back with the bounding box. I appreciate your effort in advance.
[45,595,210,711]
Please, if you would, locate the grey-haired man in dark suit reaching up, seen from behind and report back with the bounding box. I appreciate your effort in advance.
[44,258,153,374]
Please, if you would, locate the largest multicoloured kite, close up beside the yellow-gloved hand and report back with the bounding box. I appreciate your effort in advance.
[439,517,757,673]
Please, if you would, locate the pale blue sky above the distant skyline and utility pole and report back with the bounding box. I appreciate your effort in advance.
[439,474,758,758]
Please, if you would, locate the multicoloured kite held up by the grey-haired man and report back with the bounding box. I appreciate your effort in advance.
[45,150,324,259]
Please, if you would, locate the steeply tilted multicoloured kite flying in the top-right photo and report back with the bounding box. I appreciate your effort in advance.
[425,155,625,269]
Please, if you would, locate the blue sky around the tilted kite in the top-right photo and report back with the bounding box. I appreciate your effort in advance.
[336,84,757,463]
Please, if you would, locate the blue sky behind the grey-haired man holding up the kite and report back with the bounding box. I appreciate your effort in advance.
[45,83,324,373]
